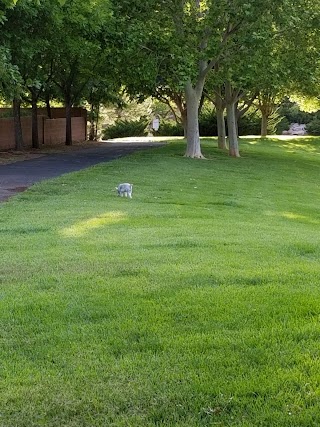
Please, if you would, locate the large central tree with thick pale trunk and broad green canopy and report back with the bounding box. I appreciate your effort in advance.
[119,0,289,158]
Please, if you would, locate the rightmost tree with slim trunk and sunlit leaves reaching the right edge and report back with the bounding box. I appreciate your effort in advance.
[252,0,320,136]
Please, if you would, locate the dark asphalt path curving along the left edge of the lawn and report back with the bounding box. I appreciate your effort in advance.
[0,142,163,202]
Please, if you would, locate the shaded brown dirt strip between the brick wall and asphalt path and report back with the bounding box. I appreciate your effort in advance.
[0,141,101,165]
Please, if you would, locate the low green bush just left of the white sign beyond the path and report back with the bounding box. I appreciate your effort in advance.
[102,117,149,139]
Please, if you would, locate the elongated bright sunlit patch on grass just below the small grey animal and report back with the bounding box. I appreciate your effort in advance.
[61,211,126,237]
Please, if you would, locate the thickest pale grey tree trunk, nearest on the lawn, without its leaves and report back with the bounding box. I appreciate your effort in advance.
[185,82,204,159]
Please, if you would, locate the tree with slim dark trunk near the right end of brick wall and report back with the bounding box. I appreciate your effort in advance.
[52,0,112,145]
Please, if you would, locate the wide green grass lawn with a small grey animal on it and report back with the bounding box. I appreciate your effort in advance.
[0,138,320,427]
